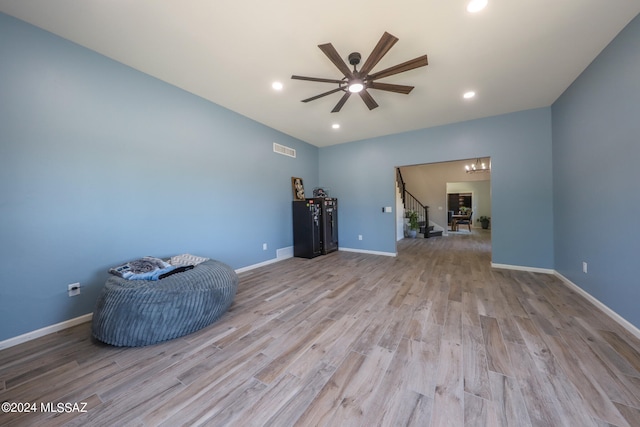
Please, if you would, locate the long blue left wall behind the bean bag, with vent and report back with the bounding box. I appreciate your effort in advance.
[0,14,318,341]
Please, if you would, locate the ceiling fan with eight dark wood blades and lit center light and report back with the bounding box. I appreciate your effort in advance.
[291,32,428,113]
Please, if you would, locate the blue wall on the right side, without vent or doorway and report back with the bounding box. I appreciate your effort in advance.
[552,16,640,327]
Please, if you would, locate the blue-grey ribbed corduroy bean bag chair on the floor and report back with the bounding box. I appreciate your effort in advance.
[91,260,238,347]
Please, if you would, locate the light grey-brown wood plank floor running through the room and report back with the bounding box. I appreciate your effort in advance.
[0,230,640,427]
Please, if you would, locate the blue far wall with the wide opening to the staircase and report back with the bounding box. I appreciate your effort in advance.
[320,108,553,269]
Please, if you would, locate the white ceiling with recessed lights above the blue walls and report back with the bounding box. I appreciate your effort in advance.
[0,0,640,147]
